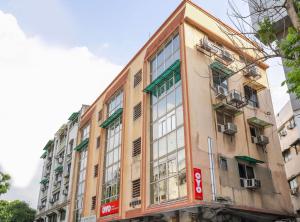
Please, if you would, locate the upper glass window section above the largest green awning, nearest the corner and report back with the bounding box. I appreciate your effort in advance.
[150,34,180,81]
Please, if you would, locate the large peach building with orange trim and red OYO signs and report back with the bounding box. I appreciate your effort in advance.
[65,0,293,221]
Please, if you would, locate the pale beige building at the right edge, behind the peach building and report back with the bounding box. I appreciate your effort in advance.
[276,102,300,218]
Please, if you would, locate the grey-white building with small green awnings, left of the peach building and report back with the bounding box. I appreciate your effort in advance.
[36,105,88,222]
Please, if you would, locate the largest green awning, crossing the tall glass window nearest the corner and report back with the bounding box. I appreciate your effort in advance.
[144,59,180,94]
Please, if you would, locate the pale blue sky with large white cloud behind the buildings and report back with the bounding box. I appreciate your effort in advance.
[0,0,288,207]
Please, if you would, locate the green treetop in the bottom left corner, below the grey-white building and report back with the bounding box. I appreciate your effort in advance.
[0,200,36,222]
